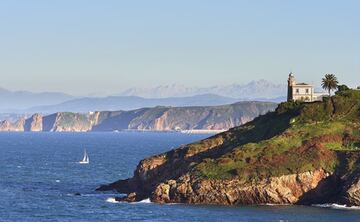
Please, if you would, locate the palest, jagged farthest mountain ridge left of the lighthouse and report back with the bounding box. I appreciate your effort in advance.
[119,80,287,100]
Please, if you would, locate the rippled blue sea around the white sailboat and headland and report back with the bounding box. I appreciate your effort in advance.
[0,132,360,222]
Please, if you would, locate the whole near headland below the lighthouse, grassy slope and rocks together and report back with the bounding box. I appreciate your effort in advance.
[98,90,360,205]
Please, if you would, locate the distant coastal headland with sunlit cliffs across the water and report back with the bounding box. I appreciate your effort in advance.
[0,102,276,132]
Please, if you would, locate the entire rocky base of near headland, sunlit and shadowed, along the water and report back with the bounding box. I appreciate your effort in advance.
[97,144,360,206]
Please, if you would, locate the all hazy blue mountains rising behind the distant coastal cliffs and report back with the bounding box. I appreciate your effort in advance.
[0,80,286,113]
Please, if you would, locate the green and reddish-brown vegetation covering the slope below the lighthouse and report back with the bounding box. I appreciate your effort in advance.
[193,90,360,181]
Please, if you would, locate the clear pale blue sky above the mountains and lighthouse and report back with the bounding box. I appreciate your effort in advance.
[0,0,360,95]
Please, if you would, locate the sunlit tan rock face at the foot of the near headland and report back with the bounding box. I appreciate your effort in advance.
[151,169,330,205]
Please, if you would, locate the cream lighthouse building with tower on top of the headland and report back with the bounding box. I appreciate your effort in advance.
[287,73,326,102]
